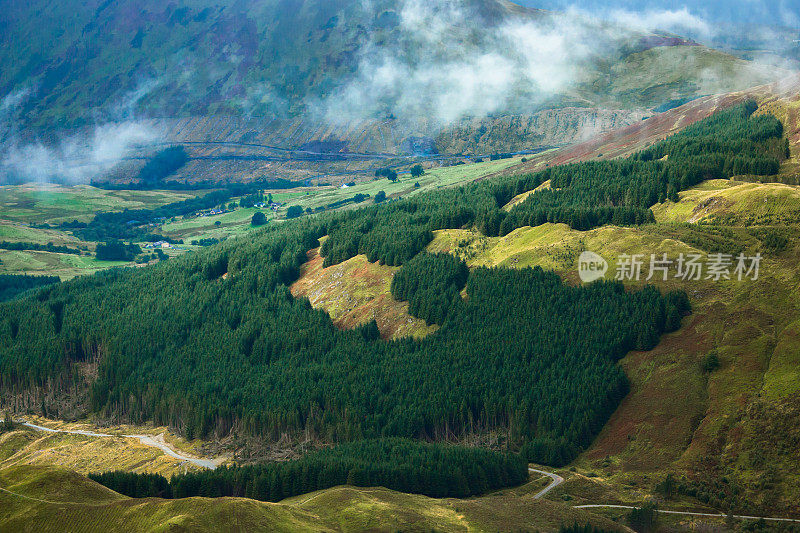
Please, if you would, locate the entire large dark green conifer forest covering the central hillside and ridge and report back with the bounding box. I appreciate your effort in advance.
[0,103,784,464]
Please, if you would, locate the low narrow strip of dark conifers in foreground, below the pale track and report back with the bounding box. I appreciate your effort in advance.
[89,438,528,502]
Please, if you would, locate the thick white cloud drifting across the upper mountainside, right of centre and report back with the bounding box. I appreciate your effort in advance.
[318,0,616,124]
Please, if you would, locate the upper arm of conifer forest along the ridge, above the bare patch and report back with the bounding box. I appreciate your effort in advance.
[322,101,788,265]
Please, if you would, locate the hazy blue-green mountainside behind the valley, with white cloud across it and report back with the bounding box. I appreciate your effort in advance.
[0,0,788,142]
